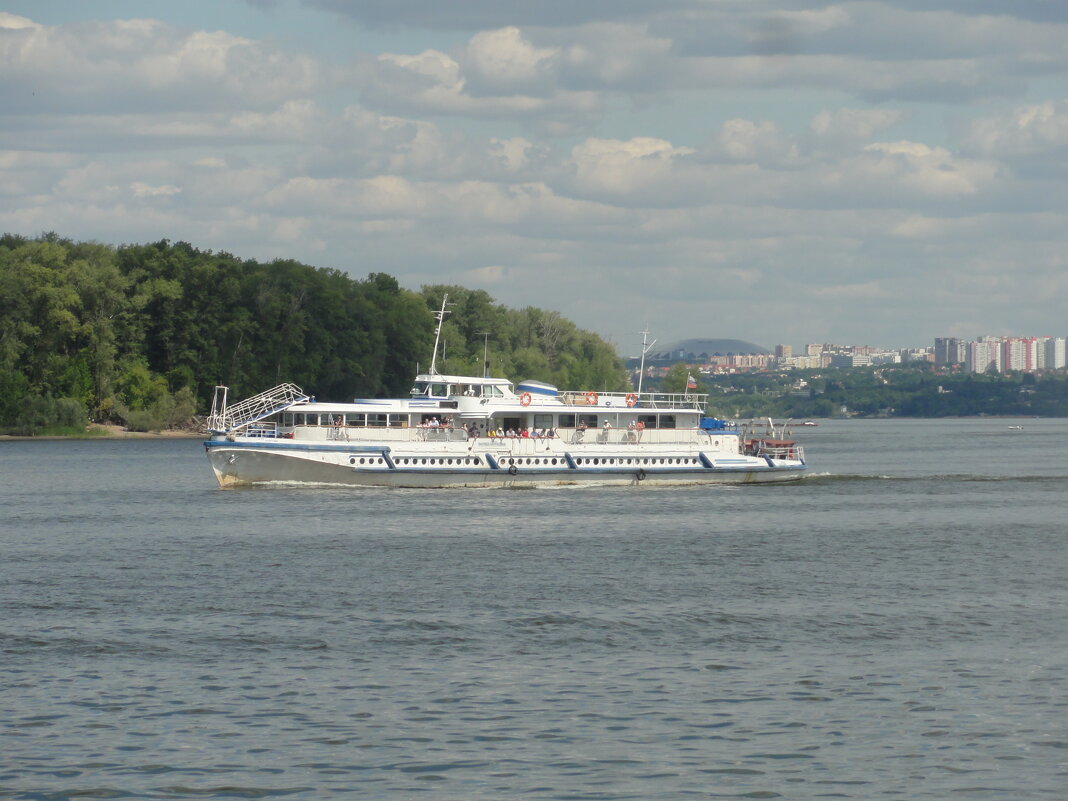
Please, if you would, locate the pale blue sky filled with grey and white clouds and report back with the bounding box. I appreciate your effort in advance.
[0,0,1068,356]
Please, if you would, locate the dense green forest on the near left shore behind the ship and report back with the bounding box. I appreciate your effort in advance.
[0,233,628,435]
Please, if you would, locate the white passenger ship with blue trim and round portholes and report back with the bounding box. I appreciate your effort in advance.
[204,307,805,487]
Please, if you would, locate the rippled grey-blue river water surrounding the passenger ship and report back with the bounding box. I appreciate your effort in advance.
[0,419,1068,800]
